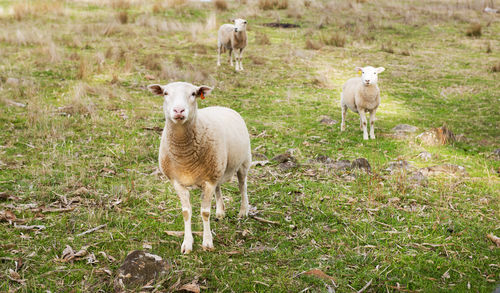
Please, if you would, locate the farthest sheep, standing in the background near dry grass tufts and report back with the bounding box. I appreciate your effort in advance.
[217,18,247,71]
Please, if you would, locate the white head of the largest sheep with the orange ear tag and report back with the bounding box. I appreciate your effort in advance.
[148,82,212,124]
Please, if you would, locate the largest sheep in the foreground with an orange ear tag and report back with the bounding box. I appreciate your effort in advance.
[148,82,252,254]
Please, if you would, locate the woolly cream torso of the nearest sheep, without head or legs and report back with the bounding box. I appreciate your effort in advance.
[159,107,251,187]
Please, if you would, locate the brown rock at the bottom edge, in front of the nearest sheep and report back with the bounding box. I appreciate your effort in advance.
[114,250,171,292]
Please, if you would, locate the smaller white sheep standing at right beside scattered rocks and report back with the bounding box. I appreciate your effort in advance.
[340,66,385,140]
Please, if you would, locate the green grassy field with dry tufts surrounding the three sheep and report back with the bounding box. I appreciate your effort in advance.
[0,0,500,292]
